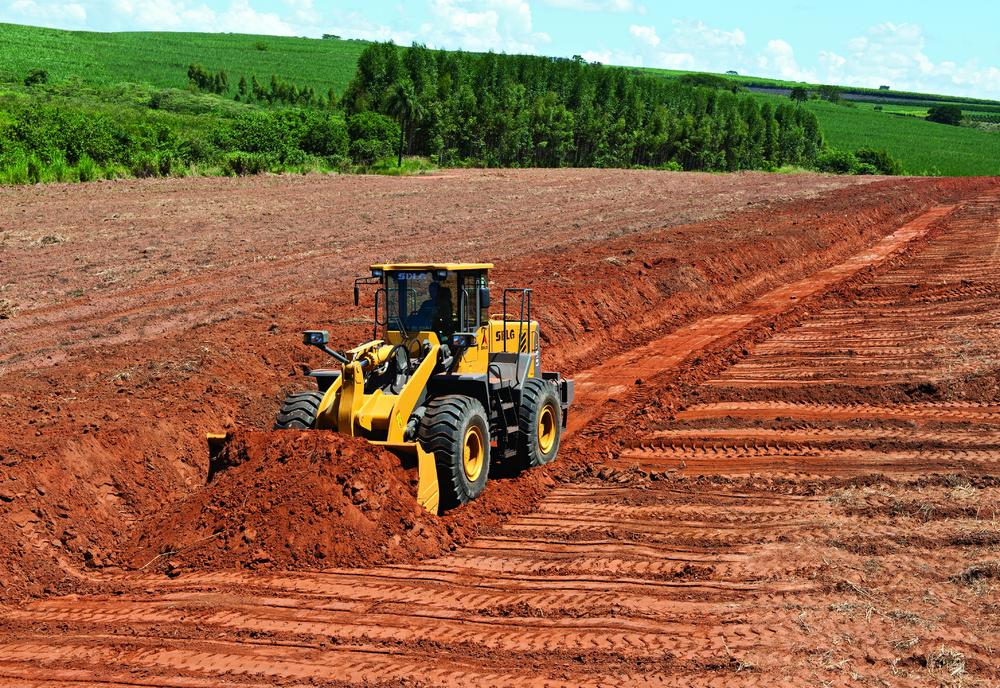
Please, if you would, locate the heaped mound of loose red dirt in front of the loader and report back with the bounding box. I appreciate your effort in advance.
[130,432,450,572]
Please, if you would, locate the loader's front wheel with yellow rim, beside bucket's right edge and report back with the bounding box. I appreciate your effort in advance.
[417,394,490,509]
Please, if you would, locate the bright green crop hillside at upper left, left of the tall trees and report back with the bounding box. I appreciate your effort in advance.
[0,24,367,94]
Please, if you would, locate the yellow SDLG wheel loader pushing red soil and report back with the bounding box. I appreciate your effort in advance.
[275,263,573,513]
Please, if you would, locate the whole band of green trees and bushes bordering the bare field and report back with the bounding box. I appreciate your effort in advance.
[0,43,916,184]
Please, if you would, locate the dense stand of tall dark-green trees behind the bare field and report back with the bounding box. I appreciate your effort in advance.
[341,43,823,171]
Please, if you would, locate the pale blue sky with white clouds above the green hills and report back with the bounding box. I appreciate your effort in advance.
[0,0,1000,98]
